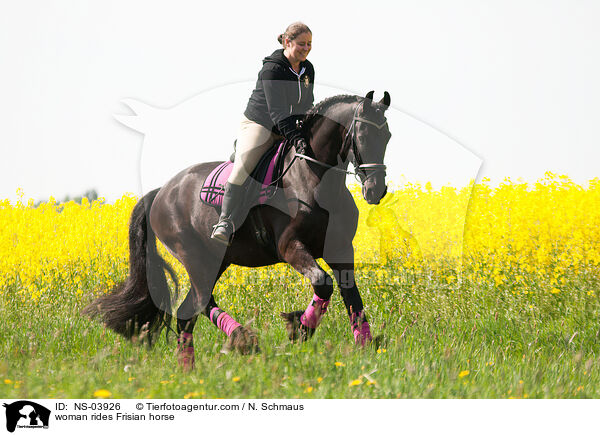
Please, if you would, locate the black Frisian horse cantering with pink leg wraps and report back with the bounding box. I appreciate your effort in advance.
[85,91,391,368]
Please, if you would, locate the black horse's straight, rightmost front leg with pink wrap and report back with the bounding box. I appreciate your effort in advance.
[325,255,373,346]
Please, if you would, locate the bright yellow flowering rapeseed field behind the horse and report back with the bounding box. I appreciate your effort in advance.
[0,173,600,301]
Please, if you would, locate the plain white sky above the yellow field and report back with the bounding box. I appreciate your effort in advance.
[0,0,600,199]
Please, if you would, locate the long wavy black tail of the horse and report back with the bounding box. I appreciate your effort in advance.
[83,189,179,344]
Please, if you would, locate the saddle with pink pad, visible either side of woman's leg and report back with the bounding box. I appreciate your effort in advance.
[200,141,292,208]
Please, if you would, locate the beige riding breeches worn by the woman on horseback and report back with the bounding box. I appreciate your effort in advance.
[228,116,283,186]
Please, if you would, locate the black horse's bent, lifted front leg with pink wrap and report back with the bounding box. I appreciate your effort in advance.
[281,240,333,341]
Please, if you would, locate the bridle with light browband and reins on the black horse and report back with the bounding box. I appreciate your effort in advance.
[296,100,387,184]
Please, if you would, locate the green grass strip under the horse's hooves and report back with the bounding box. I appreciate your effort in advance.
[0,265,600,399]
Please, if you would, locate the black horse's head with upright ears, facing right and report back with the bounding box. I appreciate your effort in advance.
[349,91,392,204]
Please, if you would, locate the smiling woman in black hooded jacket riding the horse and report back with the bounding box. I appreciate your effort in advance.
[211,22,315,244]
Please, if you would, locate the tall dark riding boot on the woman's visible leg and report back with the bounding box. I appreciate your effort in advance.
[210,183,246,246]
